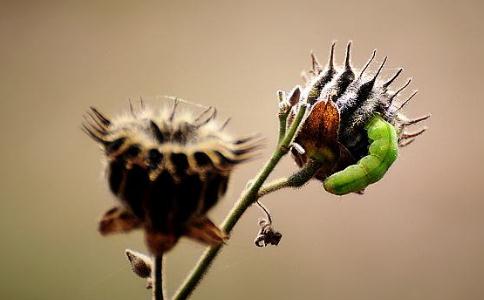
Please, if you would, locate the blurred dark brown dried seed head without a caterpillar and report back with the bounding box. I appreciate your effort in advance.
[83,99,259,254]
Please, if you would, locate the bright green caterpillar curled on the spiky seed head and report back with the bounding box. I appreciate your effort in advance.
[323,115,398,195]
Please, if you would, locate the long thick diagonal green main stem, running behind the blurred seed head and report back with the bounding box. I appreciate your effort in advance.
[173,104,307,300]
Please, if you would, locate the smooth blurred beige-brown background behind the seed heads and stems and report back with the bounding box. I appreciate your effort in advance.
[0,0,484,300]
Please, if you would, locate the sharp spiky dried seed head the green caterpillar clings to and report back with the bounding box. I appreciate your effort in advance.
[287,42,430,180]
